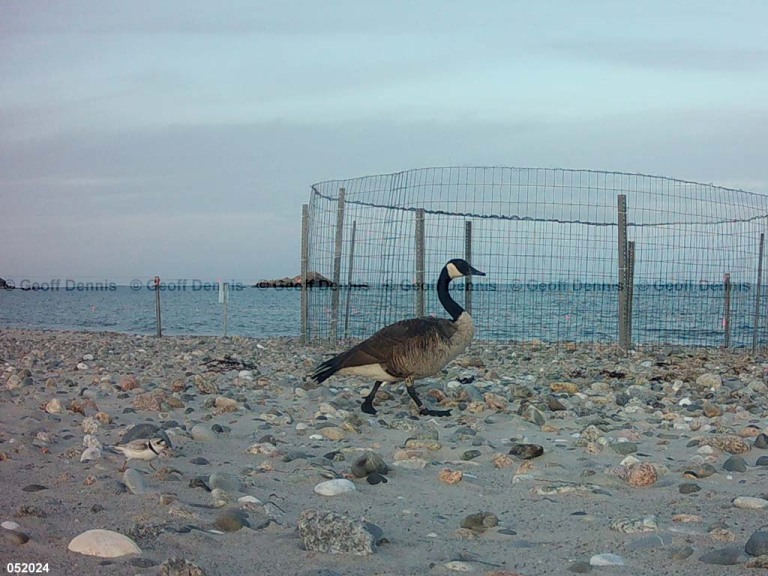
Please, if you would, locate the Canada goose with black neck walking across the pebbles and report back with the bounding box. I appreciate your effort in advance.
[311,258,485,416]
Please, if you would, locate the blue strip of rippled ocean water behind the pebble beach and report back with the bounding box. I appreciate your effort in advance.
[0,284,768,347]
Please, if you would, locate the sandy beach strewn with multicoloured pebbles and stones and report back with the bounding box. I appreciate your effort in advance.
[0,329,768,576]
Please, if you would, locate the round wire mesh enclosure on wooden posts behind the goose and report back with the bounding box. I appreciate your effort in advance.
[302,167,768,346]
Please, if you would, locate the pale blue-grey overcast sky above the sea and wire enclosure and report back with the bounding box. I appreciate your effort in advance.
[0,0,768,281]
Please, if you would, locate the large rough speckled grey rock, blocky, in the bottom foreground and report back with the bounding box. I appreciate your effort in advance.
[298,509,385,556]
